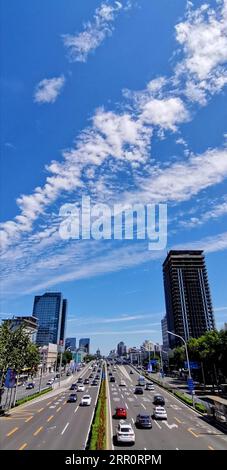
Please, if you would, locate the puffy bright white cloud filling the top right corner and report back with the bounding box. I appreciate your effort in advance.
[176,0,227,97]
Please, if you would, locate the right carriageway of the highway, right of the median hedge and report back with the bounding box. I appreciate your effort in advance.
[108,365,227,450]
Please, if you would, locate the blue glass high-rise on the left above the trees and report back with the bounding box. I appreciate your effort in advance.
[32,292,67,346]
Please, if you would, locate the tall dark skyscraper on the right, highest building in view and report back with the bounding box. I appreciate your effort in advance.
[163,250,215,348]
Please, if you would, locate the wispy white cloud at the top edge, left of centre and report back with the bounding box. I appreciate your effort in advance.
[62,2,128,62]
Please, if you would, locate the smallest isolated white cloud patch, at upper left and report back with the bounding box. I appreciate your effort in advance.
[34,75,65,103]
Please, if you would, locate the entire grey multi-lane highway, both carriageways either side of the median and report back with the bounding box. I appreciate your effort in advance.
[0,365,227,451]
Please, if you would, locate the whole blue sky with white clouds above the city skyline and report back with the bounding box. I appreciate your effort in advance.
[0,0,227,352]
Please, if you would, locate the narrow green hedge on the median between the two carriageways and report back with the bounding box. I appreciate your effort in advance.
[88,380,106,450]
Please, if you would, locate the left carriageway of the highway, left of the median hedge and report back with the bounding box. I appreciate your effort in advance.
[0,366,99,450]
